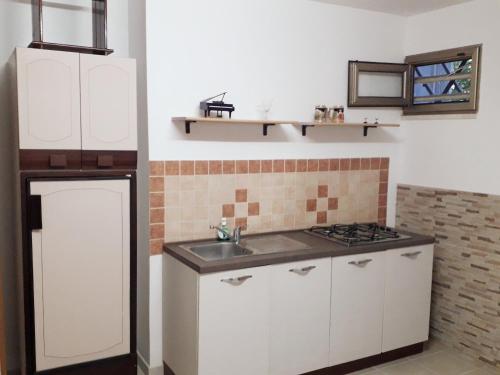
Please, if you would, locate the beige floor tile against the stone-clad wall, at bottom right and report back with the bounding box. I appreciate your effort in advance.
[412,350,482,375]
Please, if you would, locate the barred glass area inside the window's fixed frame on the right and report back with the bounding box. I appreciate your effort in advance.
[413,58,472,105]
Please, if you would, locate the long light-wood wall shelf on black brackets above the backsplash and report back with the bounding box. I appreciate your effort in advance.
[172,117,399,137]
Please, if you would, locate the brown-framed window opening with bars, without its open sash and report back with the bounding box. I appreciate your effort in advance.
[404,45,481,115]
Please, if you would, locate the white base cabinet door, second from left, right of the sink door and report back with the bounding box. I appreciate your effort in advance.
[269,258,332,375]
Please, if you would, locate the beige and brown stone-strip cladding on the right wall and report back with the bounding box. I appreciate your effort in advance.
[397,185,500,370]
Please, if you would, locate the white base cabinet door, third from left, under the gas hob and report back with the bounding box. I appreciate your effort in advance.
[330,252,385,365]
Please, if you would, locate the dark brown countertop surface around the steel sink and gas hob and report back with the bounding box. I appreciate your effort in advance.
[163,230,434,274]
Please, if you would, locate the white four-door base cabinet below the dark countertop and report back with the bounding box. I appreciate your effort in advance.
[163,245,433,375]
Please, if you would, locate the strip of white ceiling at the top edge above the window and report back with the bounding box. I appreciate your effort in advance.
[314,0,472,16]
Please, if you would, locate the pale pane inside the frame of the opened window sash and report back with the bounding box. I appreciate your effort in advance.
[358,72,403,98]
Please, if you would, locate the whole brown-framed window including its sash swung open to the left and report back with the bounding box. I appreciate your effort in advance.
[348,45,482,115]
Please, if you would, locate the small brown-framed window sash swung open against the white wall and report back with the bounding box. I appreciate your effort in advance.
[348,61,409,107]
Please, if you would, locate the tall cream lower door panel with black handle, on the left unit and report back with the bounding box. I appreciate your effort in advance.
[29,179,130,371]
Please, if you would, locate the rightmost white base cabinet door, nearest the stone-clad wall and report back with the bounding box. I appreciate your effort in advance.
[382,245,433,352]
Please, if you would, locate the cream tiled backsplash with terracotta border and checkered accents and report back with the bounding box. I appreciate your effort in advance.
[150,158,389,254]
